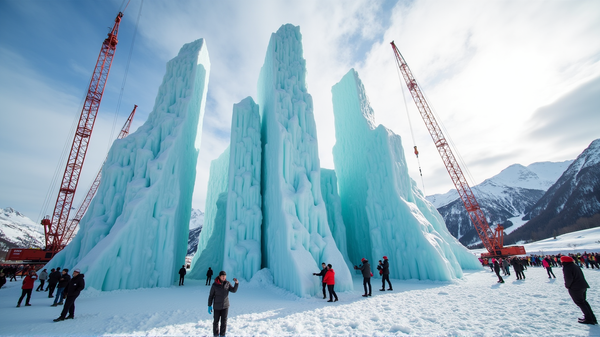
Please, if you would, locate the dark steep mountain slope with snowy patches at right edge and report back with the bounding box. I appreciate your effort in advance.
[507,139,600,242]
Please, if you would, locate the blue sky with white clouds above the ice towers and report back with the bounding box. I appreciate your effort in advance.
[0,0,600,221]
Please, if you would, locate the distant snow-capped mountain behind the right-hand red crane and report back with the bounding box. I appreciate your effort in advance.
[427,160,573,245]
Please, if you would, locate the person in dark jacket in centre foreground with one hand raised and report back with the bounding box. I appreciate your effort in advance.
[208,271,239,336]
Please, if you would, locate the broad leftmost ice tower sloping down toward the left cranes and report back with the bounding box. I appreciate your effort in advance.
[46,39,210,290]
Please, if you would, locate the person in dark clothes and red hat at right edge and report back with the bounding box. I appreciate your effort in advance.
[560,256,598,324]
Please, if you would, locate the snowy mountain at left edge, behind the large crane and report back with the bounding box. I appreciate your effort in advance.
[0,207,45,252]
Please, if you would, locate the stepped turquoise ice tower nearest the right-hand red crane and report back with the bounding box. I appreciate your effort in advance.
[332,69,480,281]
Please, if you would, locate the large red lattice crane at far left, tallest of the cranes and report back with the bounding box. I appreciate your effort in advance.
[7,12,123,261]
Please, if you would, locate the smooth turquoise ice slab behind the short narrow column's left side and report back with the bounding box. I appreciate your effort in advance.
[188,147,230,279]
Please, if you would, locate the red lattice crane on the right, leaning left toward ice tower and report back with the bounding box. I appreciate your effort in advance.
[391,41,525,257]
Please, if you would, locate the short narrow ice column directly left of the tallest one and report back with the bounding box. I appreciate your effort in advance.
[223,97,262,281]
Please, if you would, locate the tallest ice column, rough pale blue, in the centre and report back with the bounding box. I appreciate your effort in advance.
[258,24,352,297]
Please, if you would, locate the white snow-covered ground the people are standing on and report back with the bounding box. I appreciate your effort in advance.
[0,228,600,336]
